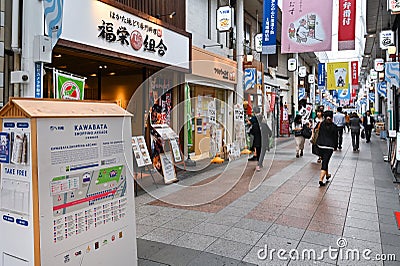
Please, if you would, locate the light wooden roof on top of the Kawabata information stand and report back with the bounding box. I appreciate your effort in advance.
[0,98,132,118]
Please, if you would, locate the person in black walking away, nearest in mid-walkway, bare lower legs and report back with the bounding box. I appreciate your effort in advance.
[317,111,339,187]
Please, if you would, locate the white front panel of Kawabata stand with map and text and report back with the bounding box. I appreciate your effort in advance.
[37,117,136,266]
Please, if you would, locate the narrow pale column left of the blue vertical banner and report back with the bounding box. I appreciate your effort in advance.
[235,0,244,104]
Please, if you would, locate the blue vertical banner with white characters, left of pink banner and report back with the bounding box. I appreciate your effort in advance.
[262,0,278,54]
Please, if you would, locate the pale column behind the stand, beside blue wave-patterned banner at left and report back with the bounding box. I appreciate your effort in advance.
[21,0,44,97]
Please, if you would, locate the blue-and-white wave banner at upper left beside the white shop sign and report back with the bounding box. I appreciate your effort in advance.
[43,0,64,48]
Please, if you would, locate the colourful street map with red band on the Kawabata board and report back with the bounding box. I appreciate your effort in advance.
[50,165,126,216]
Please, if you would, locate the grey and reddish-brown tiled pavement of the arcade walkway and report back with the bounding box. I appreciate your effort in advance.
[135,134,400,265]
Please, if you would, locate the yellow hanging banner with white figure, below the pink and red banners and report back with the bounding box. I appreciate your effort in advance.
[327,62,349,90]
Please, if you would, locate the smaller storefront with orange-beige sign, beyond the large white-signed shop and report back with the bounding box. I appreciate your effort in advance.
[185,46,237,159]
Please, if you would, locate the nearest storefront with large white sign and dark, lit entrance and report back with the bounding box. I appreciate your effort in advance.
[43,0,191,180]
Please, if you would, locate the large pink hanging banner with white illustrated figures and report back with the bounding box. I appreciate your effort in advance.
[281,0,333,54]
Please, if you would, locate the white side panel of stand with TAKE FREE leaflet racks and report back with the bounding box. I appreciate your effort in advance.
[0,119,33,265]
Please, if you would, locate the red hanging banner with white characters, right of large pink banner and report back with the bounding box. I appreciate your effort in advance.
[338,0,356,51]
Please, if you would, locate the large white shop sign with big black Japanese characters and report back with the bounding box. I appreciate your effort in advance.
[61,0,190,69]
